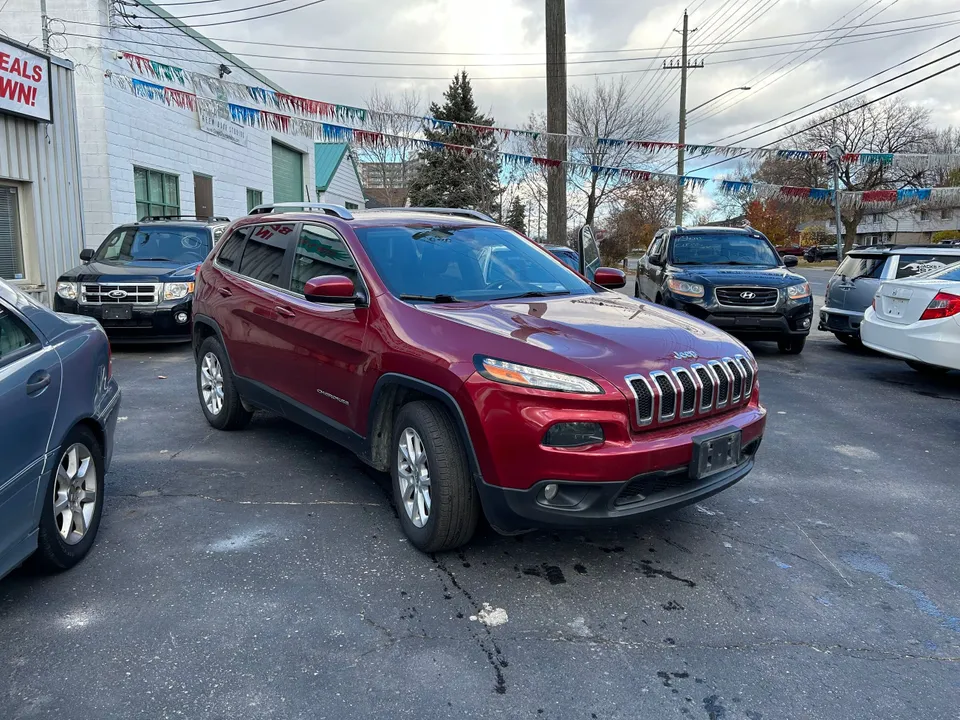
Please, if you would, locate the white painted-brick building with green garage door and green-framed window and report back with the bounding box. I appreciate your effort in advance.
[2,0,314,247]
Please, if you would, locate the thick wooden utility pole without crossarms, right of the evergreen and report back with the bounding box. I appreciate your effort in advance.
[545,0,567,245]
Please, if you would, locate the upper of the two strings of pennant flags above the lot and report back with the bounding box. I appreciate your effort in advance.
[119,52,960,172]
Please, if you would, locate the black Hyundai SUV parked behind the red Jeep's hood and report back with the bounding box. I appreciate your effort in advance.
[634,227,813,354]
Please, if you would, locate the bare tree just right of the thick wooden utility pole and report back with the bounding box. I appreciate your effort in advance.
[567,77,667,225]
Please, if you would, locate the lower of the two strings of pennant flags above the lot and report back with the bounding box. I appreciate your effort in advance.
[107,72,960,205]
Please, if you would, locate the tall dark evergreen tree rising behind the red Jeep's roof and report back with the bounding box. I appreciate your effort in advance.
[410,70,499,216]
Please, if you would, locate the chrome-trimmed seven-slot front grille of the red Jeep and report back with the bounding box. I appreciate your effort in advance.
[625,355,757,427]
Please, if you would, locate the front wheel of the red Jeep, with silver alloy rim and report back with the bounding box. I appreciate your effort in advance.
[390,401,480,552]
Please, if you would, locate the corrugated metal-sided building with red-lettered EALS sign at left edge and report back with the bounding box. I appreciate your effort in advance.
[0,35,83,303]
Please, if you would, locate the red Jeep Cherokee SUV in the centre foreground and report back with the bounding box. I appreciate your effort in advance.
[194,204,766,552]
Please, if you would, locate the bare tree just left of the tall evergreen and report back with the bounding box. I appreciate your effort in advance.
[359,88,423,207]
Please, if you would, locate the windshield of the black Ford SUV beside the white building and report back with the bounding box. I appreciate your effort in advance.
[94,227,211,265]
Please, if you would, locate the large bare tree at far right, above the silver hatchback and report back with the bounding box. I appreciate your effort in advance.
[798,98,934,250]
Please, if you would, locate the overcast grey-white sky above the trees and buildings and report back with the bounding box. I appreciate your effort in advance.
[154,0,960,179]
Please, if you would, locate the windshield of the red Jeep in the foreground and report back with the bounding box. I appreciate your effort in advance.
[356,223,594,302]
